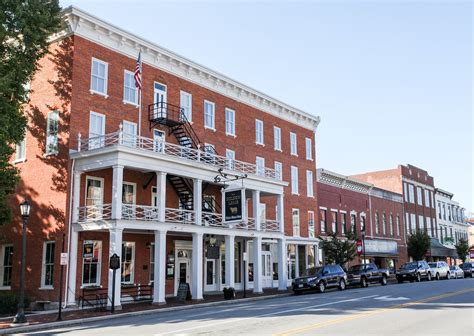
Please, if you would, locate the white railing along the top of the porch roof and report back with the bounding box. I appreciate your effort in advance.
[77,130,280,179]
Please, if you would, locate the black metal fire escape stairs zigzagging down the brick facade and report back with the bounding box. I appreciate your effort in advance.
[148,102,222,213]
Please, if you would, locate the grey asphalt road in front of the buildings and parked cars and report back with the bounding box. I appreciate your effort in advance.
[23,279,474,336]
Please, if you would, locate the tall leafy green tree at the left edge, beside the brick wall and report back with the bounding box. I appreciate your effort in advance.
[0,0,61,224]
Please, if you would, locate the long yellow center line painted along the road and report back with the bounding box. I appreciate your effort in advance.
[275,288,474,336]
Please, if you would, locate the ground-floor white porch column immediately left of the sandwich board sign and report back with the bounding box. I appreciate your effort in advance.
[153,231,166,304]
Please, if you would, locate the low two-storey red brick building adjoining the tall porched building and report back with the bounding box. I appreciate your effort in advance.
[317,168,407,271]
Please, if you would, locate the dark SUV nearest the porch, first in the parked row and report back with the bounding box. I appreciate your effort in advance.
[292,265,347,294]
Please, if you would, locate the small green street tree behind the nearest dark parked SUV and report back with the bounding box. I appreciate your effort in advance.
[319,232,357,265]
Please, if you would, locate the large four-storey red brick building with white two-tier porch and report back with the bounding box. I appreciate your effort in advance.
[0,7,319,305]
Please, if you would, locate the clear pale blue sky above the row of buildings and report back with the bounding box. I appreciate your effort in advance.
[61,0,474,210]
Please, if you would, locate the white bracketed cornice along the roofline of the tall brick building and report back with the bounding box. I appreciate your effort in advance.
[57,6,320,131]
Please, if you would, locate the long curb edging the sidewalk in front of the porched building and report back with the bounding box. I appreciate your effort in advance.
[0,293,292,335]
